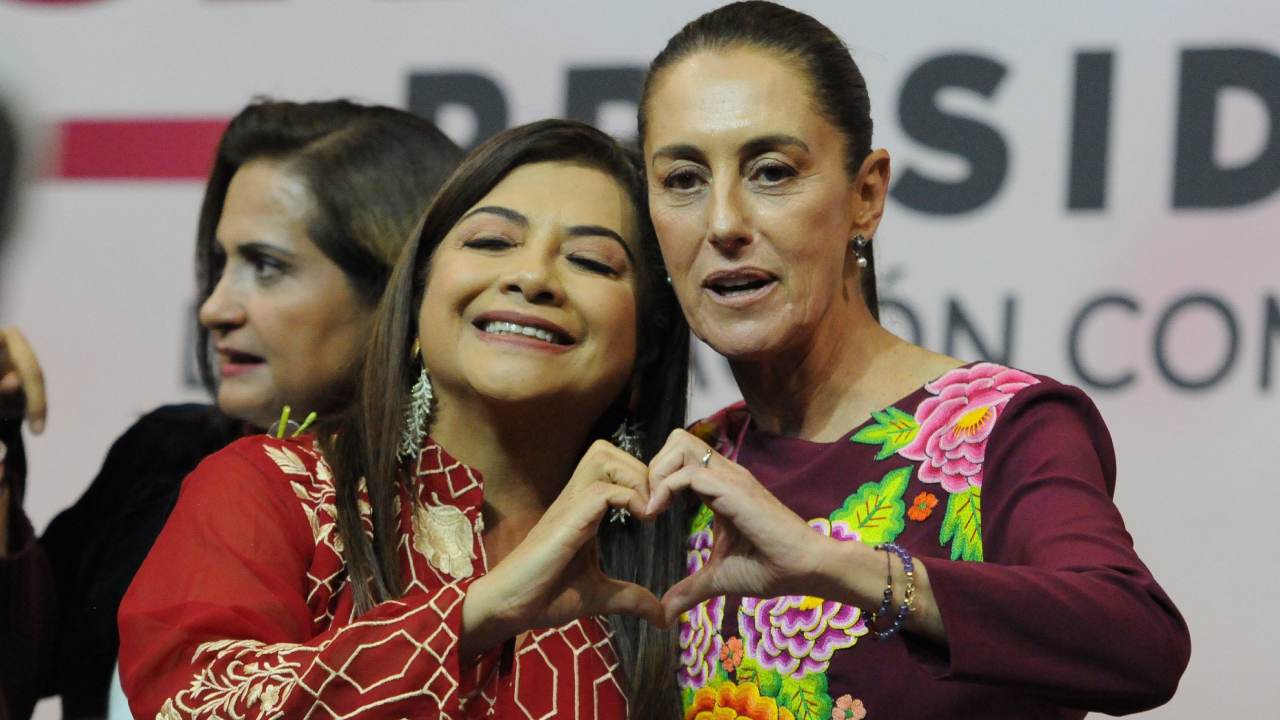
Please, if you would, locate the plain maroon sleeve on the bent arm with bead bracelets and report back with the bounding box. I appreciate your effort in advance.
[913,382,1190,714]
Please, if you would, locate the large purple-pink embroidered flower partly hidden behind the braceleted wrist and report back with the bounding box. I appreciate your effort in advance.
[737,518,867,678]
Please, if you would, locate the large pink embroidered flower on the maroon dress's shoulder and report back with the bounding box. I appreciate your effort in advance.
[899,363,1039,493]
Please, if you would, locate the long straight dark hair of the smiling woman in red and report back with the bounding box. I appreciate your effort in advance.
[321,120,689,717]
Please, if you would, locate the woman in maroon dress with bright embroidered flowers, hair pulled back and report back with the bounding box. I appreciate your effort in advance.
[640,1,1189,720]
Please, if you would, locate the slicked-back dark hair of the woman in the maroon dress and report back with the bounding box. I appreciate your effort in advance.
[639,0,879,320]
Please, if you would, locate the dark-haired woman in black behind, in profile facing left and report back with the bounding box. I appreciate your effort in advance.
[0,96,462,717]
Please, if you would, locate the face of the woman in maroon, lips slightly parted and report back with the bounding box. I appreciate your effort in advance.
[644,47,887,361]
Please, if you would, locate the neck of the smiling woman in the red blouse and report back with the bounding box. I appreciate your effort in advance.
[431,397,590,529]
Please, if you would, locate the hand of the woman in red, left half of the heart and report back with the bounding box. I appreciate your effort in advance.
[461,439,663,657]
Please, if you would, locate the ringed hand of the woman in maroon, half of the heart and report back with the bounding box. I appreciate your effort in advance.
[649,430,837,623]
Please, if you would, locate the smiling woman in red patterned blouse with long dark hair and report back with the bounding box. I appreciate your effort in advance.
[120,120,689,720]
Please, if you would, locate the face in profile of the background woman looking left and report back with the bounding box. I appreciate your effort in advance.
[200,160,372,428]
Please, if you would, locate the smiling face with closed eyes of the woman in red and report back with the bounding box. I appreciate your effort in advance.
[419,163,640,418]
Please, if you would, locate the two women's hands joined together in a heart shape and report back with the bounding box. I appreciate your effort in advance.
[463,430,827,650]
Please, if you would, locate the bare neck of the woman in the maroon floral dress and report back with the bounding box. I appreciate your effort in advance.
[730,289,911,442]
